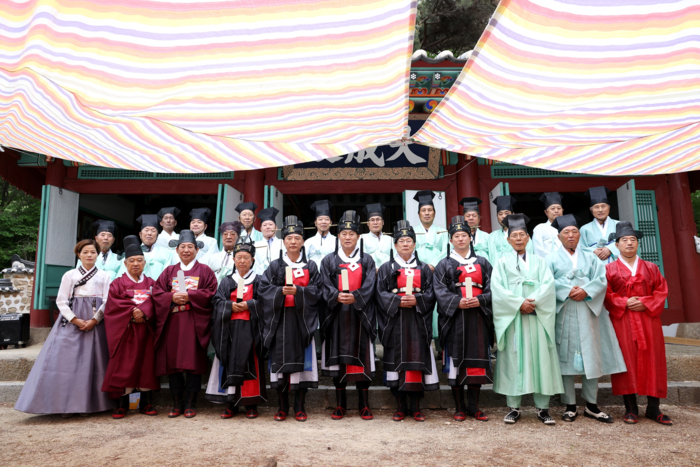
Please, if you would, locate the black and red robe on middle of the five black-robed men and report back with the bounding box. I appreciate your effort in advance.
[321,250,377,382]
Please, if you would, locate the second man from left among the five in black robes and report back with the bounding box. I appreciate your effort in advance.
[258,216,322,422]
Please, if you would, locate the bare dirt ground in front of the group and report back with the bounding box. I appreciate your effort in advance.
[0,404,700,466]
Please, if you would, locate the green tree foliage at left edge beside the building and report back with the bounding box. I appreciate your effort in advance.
[0,179,41,269]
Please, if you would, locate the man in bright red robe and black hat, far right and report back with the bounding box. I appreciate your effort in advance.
[605,222,673,425]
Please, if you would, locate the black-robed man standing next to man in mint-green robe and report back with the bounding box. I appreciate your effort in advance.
[433,216,493,422]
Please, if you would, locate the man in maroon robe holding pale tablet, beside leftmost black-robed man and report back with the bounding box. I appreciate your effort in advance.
[153,230,217,418]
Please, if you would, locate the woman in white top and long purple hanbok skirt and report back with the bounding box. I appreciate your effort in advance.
[15,240,114,416]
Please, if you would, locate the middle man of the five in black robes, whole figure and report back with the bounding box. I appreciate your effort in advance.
[321,211,377,420]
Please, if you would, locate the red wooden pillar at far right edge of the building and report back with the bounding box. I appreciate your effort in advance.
[668,173,700,323]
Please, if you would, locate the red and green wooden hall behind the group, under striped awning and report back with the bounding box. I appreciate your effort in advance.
[0,52,700,326]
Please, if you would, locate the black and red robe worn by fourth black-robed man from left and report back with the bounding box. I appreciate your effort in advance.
[375,259,439,391]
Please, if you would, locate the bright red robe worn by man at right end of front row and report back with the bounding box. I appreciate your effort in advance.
[605,258,668,399]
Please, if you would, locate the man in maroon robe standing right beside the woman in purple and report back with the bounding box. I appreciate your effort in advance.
[102,235,160,420]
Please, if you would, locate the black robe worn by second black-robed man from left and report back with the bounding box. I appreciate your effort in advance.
[258,258,322,390]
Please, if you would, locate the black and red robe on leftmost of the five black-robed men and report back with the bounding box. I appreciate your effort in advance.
[205,275,267,405]
